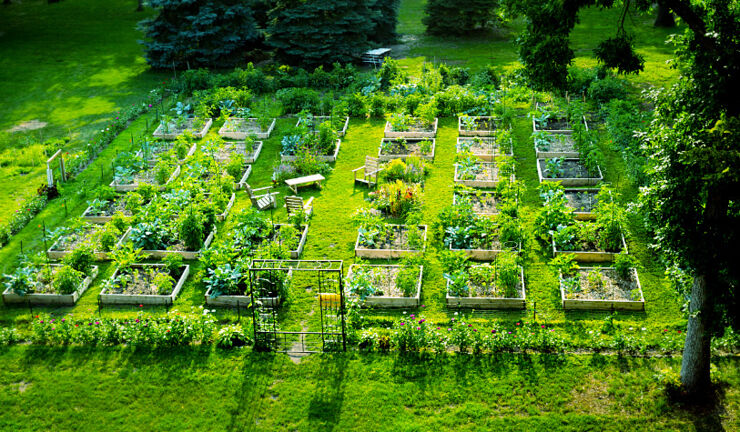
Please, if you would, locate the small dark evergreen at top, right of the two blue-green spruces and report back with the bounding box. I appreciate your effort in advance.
[422,0,502,36]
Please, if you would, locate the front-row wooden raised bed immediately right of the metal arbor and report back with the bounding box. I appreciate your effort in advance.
[347,264,424,308]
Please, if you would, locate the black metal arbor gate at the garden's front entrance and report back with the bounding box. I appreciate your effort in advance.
[249,260,347,353]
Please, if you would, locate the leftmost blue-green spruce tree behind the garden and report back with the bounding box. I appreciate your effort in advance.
[142,0,263,69]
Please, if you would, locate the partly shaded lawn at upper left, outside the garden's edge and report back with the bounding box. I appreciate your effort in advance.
[0,0,170,222]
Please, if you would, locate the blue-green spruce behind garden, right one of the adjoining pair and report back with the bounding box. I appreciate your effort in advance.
[267,0,374,66]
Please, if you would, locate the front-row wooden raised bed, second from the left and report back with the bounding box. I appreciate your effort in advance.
[100,264,190,305]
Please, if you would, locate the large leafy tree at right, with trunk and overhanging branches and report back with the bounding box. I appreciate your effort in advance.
[513,0,740,394]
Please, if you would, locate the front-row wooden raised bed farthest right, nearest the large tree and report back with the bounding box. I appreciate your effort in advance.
[560,267,645,311]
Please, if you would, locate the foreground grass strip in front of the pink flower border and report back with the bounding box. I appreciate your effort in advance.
[0,347,740,432]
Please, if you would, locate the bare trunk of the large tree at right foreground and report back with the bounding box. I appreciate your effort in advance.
[681,275,711,394]
